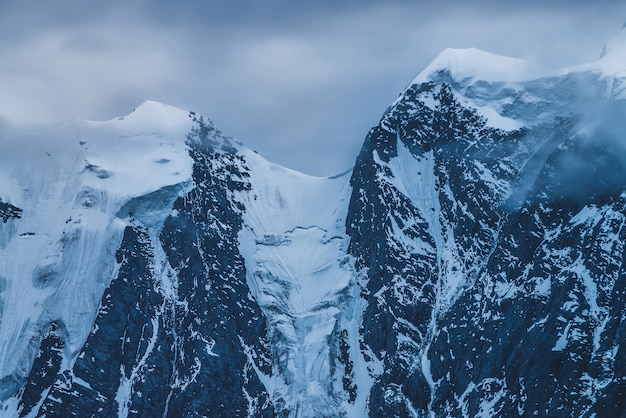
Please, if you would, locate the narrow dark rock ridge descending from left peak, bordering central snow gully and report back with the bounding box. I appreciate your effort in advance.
[156,121,273,417]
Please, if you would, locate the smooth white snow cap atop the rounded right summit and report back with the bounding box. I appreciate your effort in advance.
[413,48,535,84]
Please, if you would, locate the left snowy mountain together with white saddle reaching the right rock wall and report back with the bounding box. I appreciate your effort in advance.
[0,102,360,416]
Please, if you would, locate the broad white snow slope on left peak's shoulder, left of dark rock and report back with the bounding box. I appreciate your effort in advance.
[0,102,193,402]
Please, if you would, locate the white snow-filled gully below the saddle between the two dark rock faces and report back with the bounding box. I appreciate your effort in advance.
[239,152,360,416]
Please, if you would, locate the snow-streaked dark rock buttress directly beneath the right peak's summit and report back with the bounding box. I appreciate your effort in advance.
[346,78,528,416]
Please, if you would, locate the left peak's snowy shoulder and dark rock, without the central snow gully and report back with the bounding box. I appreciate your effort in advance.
[0,103,273,416]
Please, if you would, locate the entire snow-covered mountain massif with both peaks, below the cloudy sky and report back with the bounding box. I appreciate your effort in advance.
[0,25,626,417]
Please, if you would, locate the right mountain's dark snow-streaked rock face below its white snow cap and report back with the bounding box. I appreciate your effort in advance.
[346,39,626,416]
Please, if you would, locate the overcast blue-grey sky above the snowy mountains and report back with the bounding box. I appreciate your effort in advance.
[0,0,626,175]
